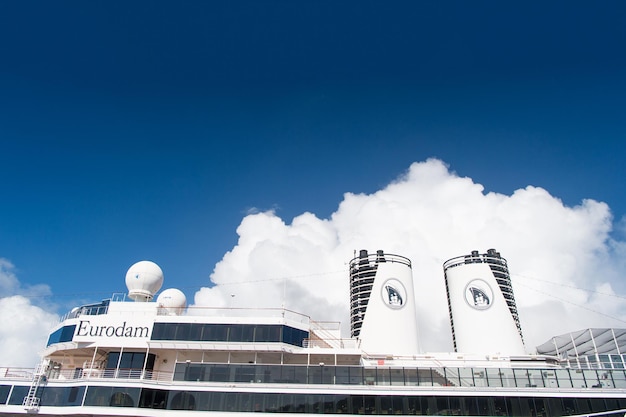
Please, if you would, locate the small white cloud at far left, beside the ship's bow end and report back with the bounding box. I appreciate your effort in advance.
[0,258,59,368]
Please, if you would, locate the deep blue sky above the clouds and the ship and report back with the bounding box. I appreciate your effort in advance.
[0,1,626,362]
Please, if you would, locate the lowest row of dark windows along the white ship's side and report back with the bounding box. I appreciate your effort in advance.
[0,385,626,417]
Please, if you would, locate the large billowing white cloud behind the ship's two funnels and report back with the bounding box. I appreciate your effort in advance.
[194,159,626,351]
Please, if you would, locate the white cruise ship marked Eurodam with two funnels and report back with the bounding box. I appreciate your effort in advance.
[0,249,626,417]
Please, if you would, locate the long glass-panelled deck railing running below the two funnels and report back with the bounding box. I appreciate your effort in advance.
[174,362,626,389]
